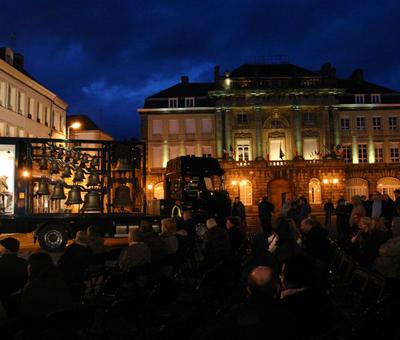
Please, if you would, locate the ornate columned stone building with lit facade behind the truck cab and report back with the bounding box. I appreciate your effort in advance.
[139,64,400,211]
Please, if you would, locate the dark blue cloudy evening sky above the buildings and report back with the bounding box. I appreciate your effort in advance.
[0,0,400,138]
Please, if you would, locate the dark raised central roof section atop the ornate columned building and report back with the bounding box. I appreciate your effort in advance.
[229,64,319,78]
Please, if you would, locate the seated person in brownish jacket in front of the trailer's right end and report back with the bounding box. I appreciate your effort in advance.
[118,230,151,272]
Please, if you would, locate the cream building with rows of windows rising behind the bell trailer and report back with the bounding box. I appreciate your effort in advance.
[0,48,68,138]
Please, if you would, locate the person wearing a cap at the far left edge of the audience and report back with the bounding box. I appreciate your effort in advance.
[0,237,28,300]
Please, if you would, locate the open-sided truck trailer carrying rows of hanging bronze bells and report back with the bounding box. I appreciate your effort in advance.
[0,137,161,251]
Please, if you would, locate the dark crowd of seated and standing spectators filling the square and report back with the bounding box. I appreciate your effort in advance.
[0,192,400,339]
